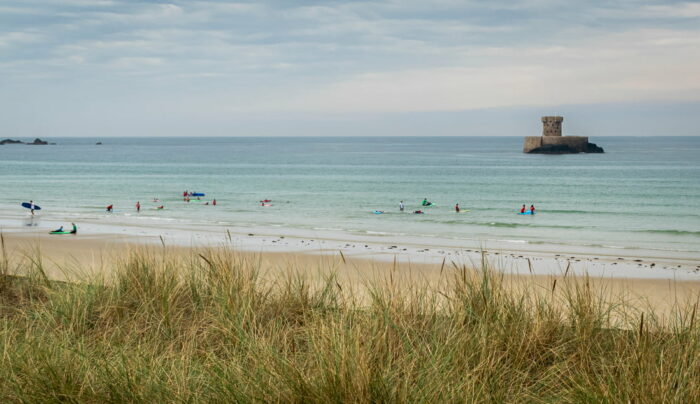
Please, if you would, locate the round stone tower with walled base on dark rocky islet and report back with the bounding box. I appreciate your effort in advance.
[523,116,604,154]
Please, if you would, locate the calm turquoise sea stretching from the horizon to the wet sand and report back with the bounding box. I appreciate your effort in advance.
[0,136,700,257]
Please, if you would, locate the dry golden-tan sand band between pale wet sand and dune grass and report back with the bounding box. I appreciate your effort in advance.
[3,233,700,318]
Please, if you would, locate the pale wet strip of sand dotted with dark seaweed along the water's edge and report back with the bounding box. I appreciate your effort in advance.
[0,218,700,281]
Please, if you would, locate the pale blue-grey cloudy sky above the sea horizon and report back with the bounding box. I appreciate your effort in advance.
[0,0,700,138]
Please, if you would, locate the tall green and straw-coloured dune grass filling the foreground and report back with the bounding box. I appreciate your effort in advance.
[0,243,700,403]
